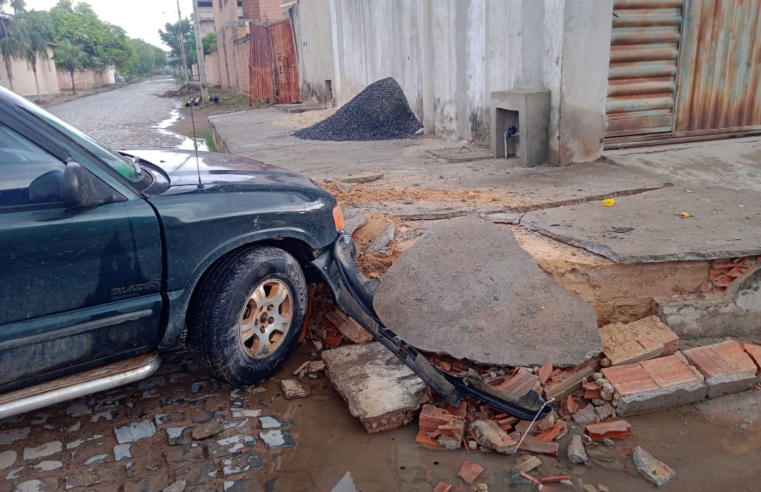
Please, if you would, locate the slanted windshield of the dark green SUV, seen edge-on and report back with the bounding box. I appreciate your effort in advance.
[13,90,144,183]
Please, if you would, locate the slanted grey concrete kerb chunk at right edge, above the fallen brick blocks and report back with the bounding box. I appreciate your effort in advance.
[657,270,761,338]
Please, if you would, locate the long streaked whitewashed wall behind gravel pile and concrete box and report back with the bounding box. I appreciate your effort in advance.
[292,0,613,164]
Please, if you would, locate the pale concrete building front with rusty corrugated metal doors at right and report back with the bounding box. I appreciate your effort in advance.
[289,0,761,164]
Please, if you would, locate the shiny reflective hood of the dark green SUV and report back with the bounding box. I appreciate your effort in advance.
[122,150,317,188]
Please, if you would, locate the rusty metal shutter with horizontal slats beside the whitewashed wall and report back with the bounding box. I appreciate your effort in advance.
[605,0,684,137]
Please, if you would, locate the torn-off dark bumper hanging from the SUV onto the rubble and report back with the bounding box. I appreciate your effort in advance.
[312,234,552,420]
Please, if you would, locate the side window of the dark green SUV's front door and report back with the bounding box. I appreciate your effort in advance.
[0,123,65,208]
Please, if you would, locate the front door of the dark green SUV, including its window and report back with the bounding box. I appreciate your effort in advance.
[0,115,162,393]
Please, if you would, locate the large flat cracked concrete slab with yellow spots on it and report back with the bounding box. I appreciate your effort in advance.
[521,187,761,264]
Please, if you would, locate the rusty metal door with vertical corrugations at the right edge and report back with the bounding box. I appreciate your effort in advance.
[674,0,761,136]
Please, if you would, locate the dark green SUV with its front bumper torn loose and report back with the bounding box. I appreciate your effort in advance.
[0,88,372,418]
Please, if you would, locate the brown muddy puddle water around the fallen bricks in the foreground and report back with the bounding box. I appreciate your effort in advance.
[278,346,761,492]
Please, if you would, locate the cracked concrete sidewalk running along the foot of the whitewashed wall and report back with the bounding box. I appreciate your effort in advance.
[210,109,761,263]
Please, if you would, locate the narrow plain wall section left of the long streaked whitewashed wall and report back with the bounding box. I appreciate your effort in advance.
[290,0,335,103]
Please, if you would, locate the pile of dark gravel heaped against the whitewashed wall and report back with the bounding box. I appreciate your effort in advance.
[294,77,423,142]
